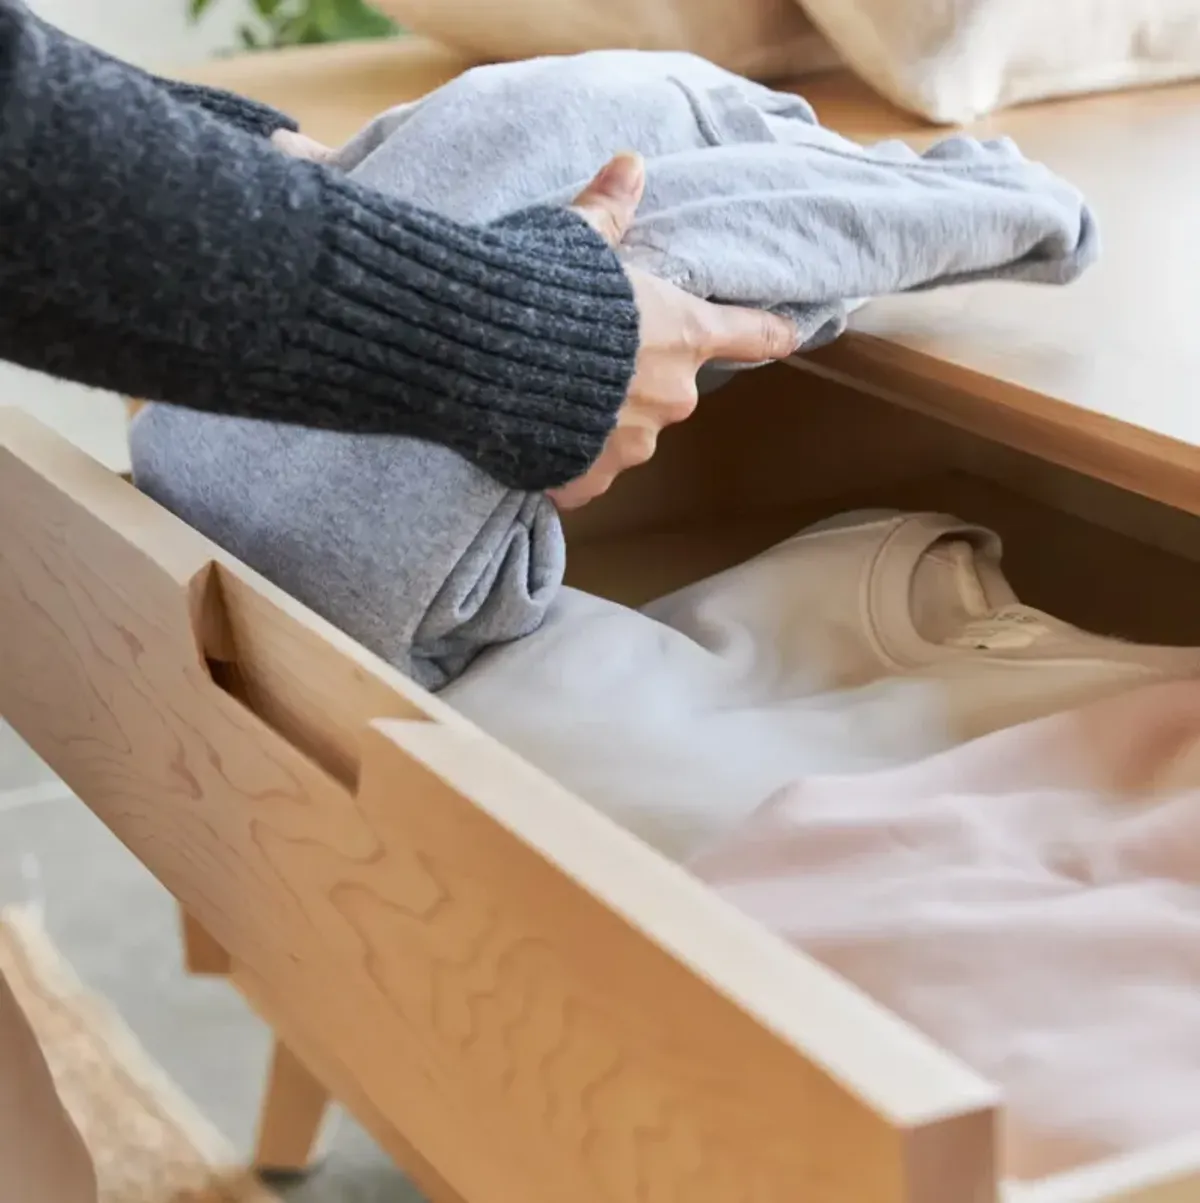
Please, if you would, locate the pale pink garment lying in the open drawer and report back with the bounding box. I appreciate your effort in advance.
[691,680,1200,1179]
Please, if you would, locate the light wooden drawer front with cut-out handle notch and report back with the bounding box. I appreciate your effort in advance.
[0,414,996,1203]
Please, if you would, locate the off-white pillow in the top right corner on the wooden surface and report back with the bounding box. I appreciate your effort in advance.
[801,0,1200,124]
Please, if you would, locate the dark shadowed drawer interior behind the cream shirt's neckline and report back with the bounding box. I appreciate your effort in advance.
[566,366,1200,645]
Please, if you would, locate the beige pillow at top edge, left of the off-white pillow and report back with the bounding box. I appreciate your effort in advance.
[378,0,841,79]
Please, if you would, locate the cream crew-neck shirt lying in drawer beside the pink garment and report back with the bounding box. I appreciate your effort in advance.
[442,511,1200,859]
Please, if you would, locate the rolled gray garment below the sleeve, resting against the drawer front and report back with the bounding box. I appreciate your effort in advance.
[130,405,564,688]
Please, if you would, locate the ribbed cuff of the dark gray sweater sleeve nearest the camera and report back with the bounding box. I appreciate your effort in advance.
[246,173,638,490]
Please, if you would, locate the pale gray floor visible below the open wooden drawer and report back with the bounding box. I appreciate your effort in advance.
[0,725,420,1203]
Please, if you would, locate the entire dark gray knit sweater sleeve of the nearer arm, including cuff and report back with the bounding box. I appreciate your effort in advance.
[0,0,637,488]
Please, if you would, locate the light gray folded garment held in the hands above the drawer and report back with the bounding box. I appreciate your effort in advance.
[339,51,1098,349]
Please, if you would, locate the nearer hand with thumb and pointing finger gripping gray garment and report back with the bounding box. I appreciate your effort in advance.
[549,154,797,510]
